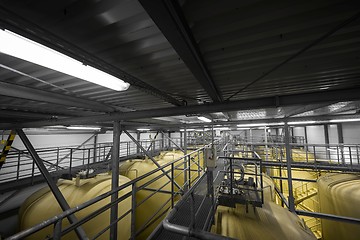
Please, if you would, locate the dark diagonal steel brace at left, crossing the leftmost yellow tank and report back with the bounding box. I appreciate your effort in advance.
[16,129,88,239]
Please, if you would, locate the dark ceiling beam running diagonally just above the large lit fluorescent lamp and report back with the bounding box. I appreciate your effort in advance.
[0,6,184,106]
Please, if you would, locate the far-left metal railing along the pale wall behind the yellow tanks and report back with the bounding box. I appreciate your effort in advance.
[0,139,208,185]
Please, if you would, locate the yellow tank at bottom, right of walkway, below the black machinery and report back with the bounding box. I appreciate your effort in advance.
[211,202,316,240]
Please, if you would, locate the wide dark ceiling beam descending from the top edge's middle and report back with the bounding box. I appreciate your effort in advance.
[139,0,223,102]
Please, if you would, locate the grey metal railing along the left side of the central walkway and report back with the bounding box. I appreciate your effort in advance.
[7,144,210,239]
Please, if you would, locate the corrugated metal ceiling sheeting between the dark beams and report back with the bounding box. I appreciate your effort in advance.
[0,0,360,129]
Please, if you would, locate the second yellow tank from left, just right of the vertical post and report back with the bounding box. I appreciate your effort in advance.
[120,160,171,239]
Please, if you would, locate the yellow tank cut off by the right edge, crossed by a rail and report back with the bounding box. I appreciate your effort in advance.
[318,173,360,240]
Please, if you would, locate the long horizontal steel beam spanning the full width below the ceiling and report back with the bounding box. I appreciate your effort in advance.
[0,88,360,129]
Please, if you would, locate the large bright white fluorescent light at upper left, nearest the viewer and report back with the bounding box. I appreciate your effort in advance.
[0,30,130,91]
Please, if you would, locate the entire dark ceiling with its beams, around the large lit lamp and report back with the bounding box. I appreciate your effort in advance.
[0,0,360,129]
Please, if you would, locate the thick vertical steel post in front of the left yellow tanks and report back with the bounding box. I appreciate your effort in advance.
[110,121,121,239]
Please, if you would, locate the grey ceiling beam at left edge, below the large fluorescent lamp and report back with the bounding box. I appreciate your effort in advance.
[0,82,115,112]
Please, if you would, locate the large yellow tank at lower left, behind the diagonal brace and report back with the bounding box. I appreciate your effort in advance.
[19,174,131,240]
